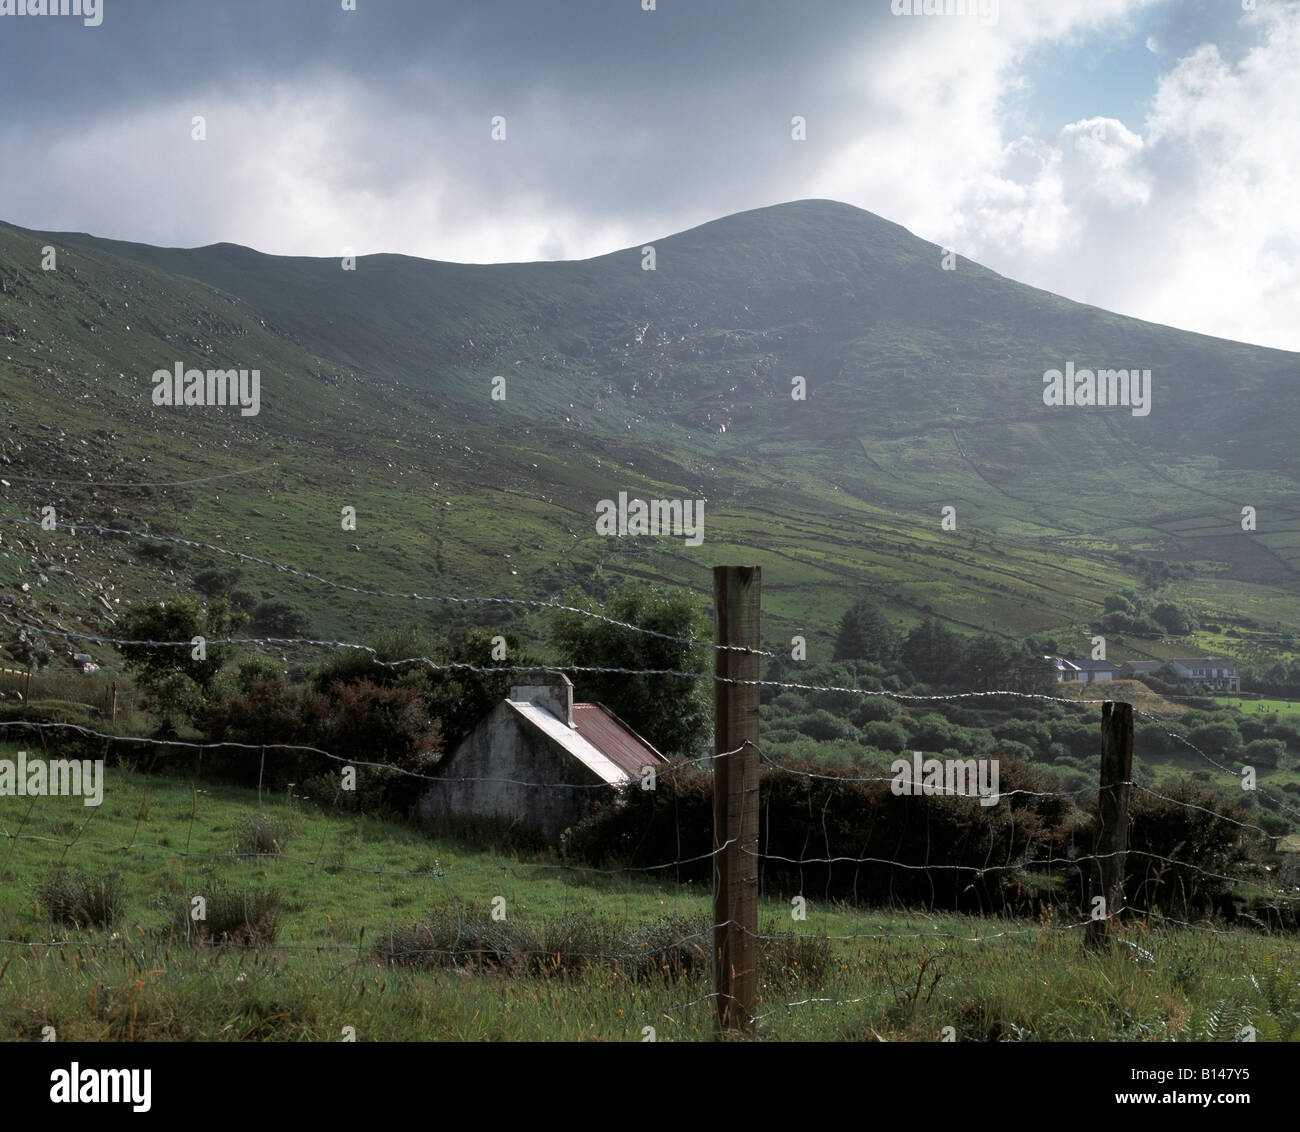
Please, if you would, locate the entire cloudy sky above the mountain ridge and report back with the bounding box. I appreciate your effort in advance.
[0,0,1300,350]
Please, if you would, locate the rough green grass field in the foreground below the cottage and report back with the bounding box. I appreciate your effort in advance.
[0,747,1300,1041]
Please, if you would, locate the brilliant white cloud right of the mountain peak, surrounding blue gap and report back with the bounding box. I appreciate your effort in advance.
[818,3,1300,350]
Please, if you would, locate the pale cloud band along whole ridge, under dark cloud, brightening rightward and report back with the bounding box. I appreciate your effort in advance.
[0,0,1300,350]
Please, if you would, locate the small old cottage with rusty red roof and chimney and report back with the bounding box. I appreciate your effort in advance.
[420,671,668,838]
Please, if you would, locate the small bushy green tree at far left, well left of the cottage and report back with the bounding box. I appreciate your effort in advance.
[117,598,248,730]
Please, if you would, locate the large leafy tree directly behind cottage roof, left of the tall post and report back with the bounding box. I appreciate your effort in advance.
[550,582,712,756]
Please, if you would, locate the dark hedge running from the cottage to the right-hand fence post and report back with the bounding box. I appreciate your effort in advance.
[566,758,1074,912]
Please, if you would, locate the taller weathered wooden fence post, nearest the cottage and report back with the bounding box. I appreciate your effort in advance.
[714,567,762,1031]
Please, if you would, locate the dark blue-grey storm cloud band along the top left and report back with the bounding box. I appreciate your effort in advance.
[0,0,887,121]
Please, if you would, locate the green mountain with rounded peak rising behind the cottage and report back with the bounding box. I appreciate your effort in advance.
[0,200,1300,659]
